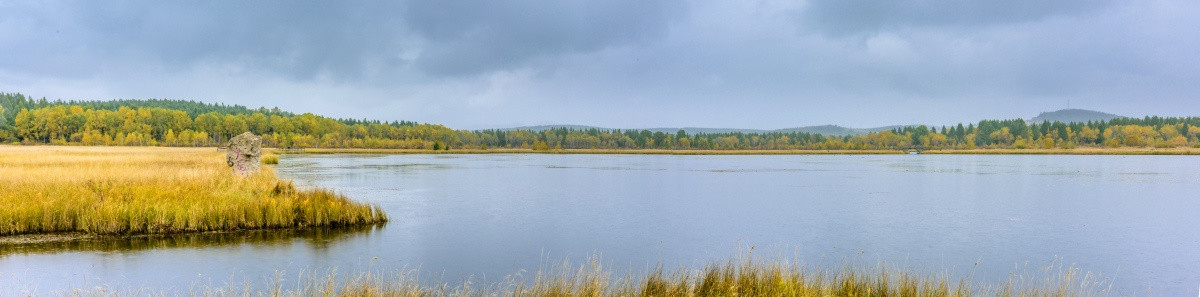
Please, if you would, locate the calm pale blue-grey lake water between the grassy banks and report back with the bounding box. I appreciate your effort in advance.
[0,154,1200,296]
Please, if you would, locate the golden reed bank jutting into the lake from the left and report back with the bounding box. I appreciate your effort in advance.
[0,146,388,236]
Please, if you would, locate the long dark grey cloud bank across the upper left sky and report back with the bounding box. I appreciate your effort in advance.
[0,0,685,80]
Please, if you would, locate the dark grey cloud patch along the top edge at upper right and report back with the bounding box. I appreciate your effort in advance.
[802,0,1115,35]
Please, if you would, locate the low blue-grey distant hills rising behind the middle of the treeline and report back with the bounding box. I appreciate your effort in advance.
[500,125,905,137]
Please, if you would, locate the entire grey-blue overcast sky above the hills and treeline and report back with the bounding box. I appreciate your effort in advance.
[0,0,1200,129]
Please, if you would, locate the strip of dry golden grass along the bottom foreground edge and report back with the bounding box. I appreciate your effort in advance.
[75,256,1112,297]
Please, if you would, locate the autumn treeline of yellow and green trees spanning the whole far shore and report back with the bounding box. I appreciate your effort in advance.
[0,93,1200,150]
